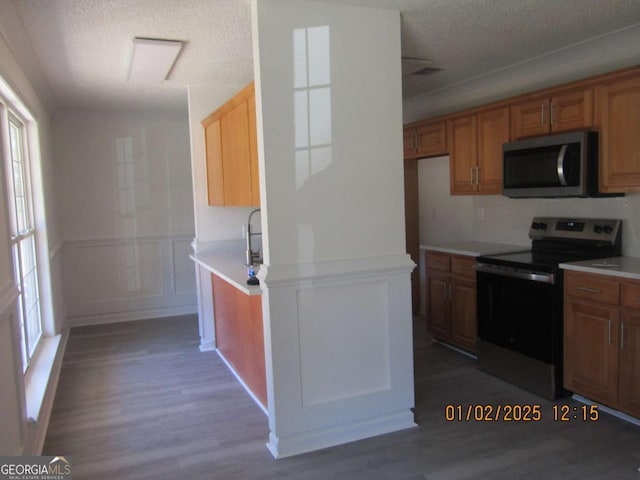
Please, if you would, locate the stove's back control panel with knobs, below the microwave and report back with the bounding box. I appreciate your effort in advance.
[529,217,622,245]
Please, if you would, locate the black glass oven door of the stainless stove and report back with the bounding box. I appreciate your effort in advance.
[477,264,562,364]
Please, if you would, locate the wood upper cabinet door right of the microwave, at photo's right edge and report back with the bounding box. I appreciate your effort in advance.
[596,74,640,192]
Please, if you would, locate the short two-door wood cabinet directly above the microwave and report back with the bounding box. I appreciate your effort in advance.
[511,87,594,139]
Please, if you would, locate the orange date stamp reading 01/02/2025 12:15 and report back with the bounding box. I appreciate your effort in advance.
[444,404,600,422]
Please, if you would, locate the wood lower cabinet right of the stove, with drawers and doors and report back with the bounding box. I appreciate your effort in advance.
[564,271,640,417]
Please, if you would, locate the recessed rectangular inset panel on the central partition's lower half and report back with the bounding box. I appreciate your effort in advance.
[298,282,390,407]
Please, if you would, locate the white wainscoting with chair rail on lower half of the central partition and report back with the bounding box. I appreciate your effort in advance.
[258,255,415,457]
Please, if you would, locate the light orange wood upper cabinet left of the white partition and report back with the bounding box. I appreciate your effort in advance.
[202,84,260,206]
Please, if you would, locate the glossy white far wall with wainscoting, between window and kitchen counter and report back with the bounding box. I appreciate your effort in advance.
[54,110,196,324]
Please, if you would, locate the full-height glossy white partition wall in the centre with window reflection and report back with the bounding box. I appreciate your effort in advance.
[253,0,415,457]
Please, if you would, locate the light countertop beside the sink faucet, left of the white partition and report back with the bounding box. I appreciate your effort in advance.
[189,240,262,295]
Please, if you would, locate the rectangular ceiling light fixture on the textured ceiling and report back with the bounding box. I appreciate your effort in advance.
[127,37,182,83]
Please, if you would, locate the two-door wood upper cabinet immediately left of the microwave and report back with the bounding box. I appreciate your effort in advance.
[447,107,510,194]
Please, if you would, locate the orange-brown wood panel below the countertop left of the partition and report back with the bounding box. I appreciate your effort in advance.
[211,274,267,407]
